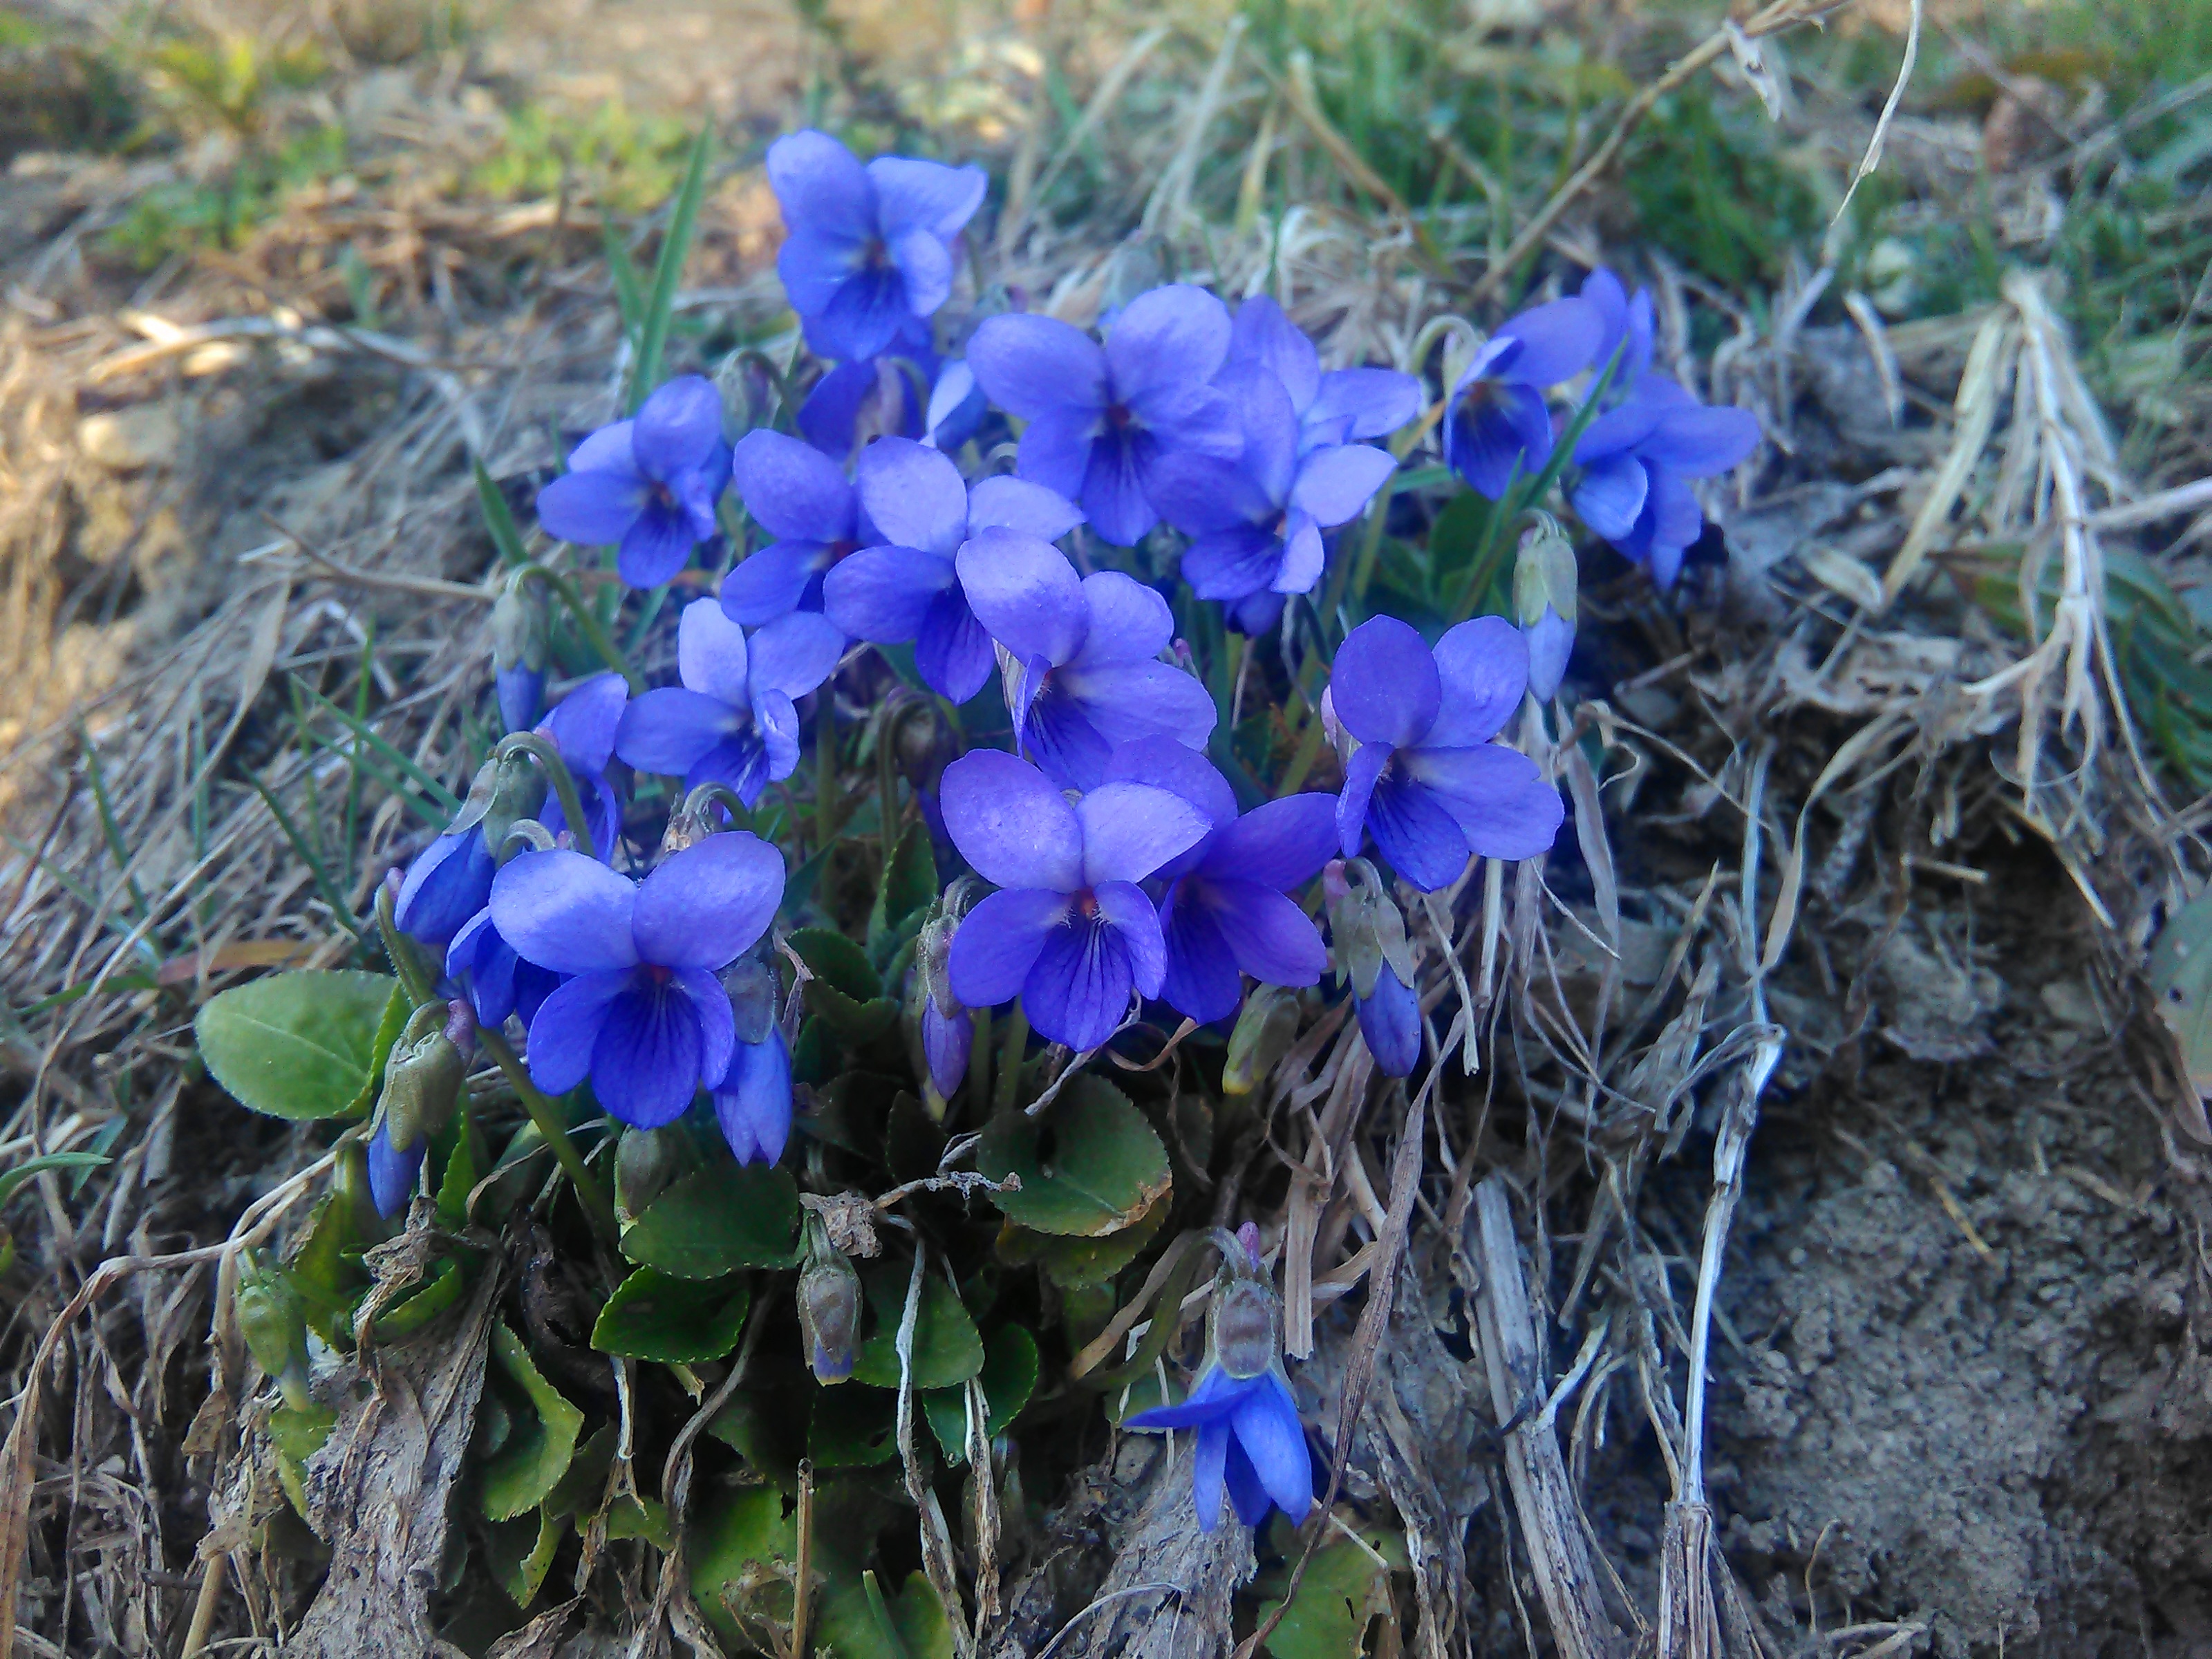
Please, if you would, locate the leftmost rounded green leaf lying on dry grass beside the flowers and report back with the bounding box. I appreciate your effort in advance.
[192,969,394,1121]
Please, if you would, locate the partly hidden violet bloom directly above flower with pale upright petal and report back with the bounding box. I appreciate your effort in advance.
[721,429,881,628]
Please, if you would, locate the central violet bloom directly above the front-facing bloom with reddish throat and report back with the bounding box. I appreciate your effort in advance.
[955,529,1217,789]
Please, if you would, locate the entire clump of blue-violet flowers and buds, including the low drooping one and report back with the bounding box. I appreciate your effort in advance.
[372,133,1759,1528]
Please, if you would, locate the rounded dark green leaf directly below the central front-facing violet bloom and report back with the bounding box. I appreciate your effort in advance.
[975,1073,1170,1239]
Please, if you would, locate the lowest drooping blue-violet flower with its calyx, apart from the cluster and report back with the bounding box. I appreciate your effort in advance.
[1121,1226,1314,1533]
